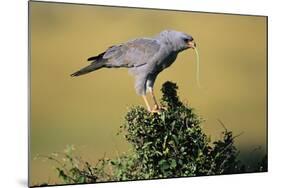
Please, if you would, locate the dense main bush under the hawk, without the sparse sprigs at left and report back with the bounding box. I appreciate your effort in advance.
[112,82,241,180]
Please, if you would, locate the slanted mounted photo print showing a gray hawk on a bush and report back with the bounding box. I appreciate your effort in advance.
[29,1,268,187]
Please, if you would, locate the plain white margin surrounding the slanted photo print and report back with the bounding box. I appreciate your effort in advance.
[0,0,281,188]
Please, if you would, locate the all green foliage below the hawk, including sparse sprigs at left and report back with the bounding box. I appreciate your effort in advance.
[38,82,267,187]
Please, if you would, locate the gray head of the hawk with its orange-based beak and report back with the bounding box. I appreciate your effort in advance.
[159,30,196,52]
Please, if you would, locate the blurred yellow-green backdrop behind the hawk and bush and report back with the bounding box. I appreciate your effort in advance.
[29,2,267,184]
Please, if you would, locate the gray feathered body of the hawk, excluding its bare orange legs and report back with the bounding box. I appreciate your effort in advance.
[71,30,195,95]
